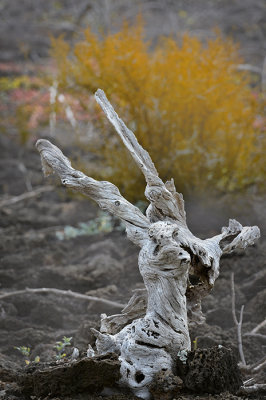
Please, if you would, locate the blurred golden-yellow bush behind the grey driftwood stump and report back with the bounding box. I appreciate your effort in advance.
[50,22,266,199]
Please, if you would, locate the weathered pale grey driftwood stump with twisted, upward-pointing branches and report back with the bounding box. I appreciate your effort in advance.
[36,90,260,399]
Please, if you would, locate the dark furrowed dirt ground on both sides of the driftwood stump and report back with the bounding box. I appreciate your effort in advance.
[0,136,266,400]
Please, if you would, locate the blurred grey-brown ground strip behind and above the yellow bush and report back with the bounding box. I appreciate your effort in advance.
[0,0,266,68]
